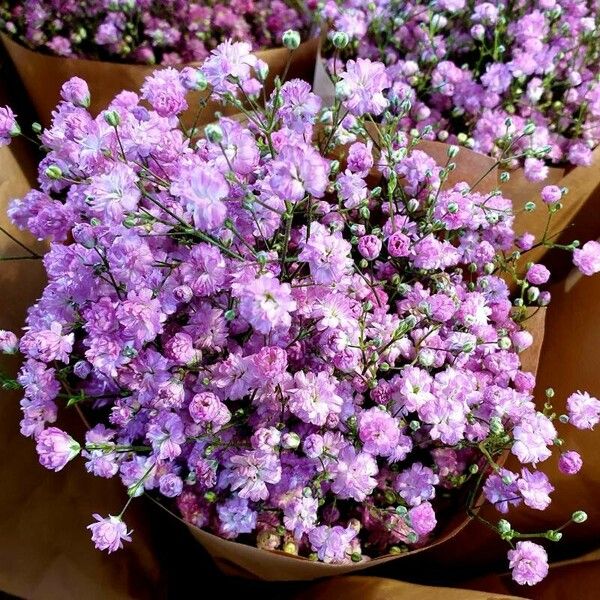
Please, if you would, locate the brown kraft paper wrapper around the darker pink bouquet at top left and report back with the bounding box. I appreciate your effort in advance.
[1,34,318,126]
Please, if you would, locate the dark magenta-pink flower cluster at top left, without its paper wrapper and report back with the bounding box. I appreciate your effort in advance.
[0,0,310,65]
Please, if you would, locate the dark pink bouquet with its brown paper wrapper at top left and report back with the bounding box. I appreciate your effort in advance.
[0,0,317,127]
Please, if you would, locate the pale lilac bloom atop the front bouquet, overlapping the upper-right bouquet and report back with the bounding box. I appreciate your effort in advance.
[338,58,391,116]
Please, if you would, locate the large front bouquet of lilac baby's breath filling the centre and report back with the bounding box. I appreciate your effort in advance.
[0,42,600,584]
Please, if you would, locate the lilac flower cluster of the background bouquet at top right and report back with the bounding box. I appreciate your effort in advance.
[321,0,600,176]
